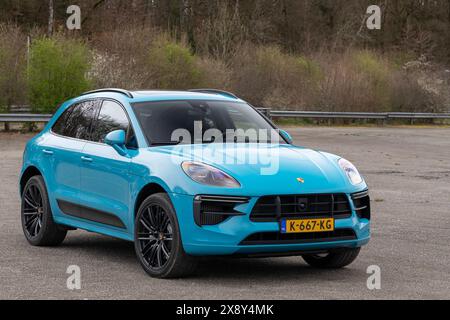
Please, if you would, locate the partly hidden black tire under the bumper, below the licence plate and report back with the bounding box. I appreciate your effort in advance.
[302,248,361,269]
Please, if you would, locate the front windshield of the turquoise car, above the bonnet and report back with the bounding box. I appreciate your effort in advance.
[132,100,285,146]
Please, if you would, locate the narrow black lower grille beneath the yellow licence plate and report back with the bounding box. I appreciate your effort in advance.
[240,229,356,246]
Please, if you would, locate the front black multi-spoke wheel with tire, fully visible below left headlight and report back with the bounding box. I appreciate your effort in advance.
[134,193,197,279]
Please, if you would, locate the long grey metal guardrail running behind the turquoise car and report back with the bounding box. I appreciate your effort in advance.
[0,108,450,122]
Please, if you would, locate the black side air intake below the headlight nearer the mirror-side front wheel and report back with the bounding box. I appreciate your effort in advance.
[194,196,248,226]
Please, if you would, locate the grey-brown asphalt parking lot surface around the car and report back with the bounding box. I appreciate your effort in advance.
[0,127,450,300]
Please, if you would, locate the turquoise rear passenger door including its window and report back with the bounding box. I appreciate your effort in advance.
[45,100,98,215]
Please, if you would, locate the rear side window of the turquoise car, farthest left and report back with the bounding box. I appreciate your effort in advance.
[52,100,99,140]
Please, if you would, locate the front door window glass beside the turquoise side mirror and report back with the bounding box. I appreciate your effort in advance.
[91,100,130,142]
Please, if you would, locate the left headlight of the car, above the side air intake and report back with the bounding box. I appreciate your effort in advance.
[181,161,241,188]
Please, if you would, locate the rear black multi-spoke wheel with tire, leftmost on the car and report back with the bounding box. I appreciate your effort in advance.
[21,176,67,247]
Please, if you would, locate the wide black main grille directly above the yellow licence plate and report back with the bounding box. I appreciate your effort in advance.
[250,194,352,222]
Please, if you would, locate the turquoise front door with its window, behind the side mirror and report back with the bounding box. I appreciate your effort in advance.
[80,100,133,230]
